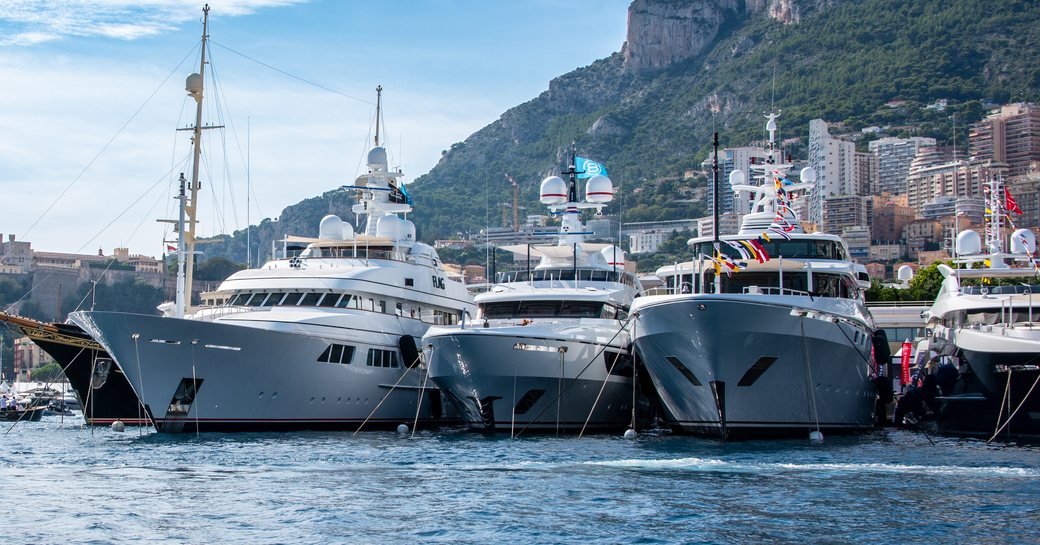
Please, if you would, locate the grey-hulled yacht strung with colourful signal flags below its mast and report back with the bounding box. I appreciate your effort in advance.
[631,114,877,438]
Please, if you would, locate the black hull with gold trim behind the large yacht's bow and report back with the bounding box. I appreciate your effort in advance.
[23,325,151,425]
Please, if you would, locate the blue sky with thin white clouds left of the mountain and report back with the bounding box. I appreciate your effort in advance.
[0,0,629,257]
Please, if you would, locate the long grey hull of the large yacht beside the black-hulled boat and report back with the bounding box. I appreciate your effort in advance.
[73,312,458,433]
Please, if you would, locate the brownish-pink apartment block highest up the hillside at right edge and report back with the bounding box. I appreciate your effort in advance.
[968,103,1040,178]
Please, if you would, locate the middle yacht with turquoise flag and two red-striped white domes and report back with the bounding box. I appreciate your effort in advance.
[422,153,641,435]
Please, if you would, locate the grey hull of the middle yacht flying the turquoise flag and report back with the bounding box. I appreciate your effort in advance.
[423,321,633,433]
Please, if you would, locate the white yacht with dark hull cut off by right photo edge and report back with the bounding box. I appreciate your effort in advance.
[924,168,1040,439]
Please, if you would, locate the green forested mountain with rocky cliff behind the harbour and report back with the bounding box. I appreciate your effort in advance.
[200,0,1040,262]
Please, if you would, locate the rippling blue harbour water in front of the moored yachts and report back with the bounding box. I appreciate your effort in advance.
[0,416,1040,544]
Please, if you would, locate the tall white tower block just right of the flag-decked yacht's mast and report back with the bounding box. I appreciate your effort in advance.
[806,120,856,224]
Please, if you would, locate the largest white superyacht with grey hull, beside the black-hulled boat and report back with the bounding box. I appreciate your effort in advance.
[72,89,475,432]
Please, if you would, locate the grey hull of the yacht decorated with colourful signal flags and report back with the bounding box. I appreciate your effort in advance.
[633,294,876,438]
